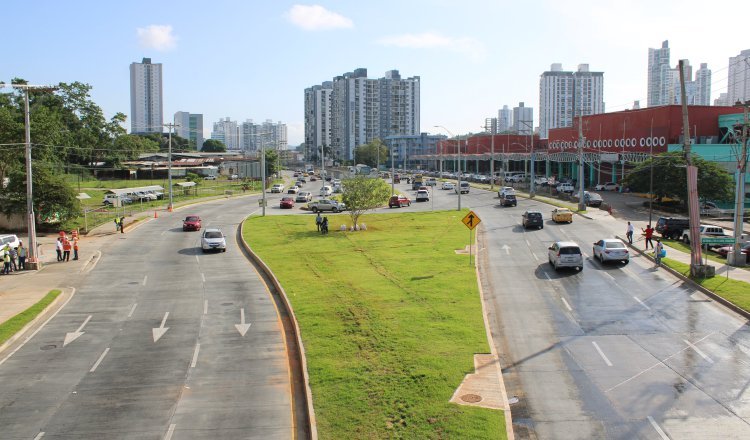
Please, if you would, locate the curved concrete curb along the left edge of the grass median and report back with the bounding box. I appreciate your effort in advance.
[238,216,318,440]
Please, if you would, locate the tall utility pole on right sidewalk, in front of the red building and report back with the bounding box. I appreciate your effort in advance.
[679,60,708,277]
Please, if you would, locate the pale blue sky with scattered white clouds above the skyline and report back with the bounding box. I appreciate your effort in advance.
[5,0,750,147]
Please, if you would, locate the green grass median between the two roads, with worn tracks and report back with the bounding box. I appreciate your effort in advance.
[244,211,506,439]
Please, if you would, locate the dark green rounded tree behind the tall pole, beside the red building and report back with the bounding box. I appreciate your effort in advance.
[624,152,732,205]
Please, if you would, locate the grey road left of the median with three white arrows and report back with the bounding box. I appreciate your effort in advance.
[0,198,293,440]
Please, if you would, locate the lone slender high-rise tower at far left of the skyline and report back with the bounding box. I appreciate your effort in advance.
[130,58,164,133]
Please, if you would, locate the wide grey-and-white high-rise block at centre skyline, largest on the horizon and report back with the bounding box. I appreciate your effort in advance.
[305,68,420,160]
